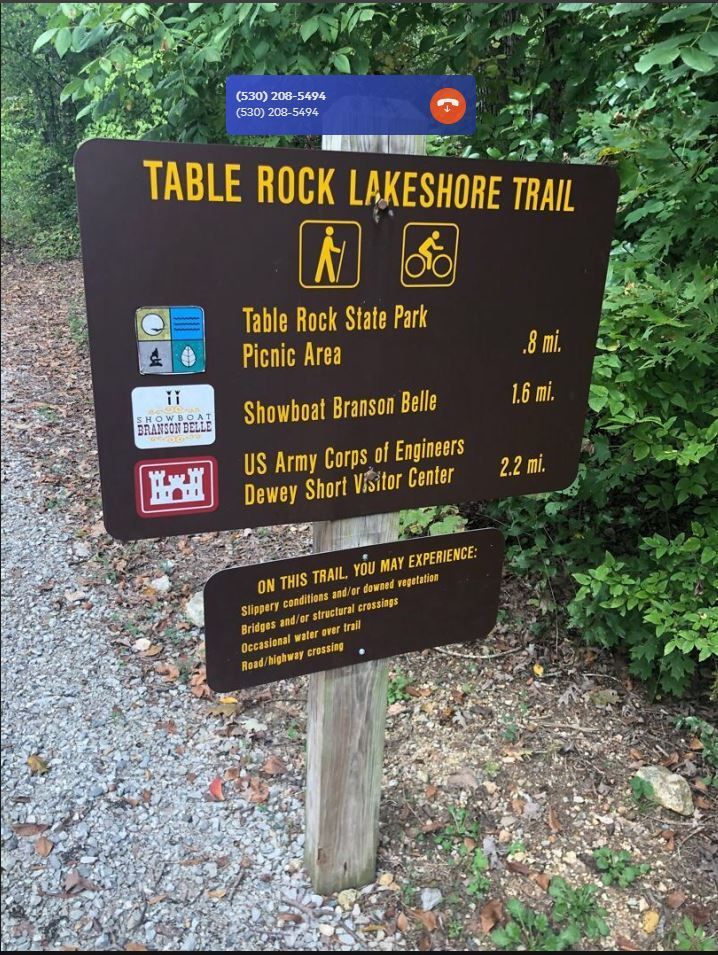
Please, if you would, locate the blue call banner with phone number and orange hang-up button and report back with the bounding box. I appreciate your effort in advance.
[226,75,476,136]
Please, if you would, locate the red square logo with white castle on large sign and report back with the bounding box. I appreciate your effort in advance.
[135,456,219,517]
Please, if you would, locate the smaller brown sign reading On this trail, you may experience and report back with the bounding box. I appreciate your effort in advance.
[204,529,504,691]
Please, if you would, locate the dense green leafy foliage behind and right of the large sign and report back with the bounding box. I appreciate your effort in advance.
[3,3,718,693]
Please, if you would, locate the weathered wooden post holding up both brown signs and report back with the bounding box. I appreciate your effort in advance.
[304,136,426,895]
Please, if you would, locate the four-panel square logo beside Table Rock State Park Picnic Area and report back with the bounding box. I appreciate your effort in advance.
[135,305,206,375]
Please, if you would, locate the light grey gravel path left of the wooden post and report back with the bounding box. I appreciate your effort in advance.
[2,452,404,951]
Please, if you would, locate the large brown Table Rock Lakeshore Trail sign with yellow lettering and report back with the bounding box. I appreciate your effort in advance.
[76,140,617,539]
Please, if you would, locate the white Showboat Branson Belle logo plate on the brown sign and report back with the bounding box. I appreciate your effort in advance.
[132,385,216,448]
